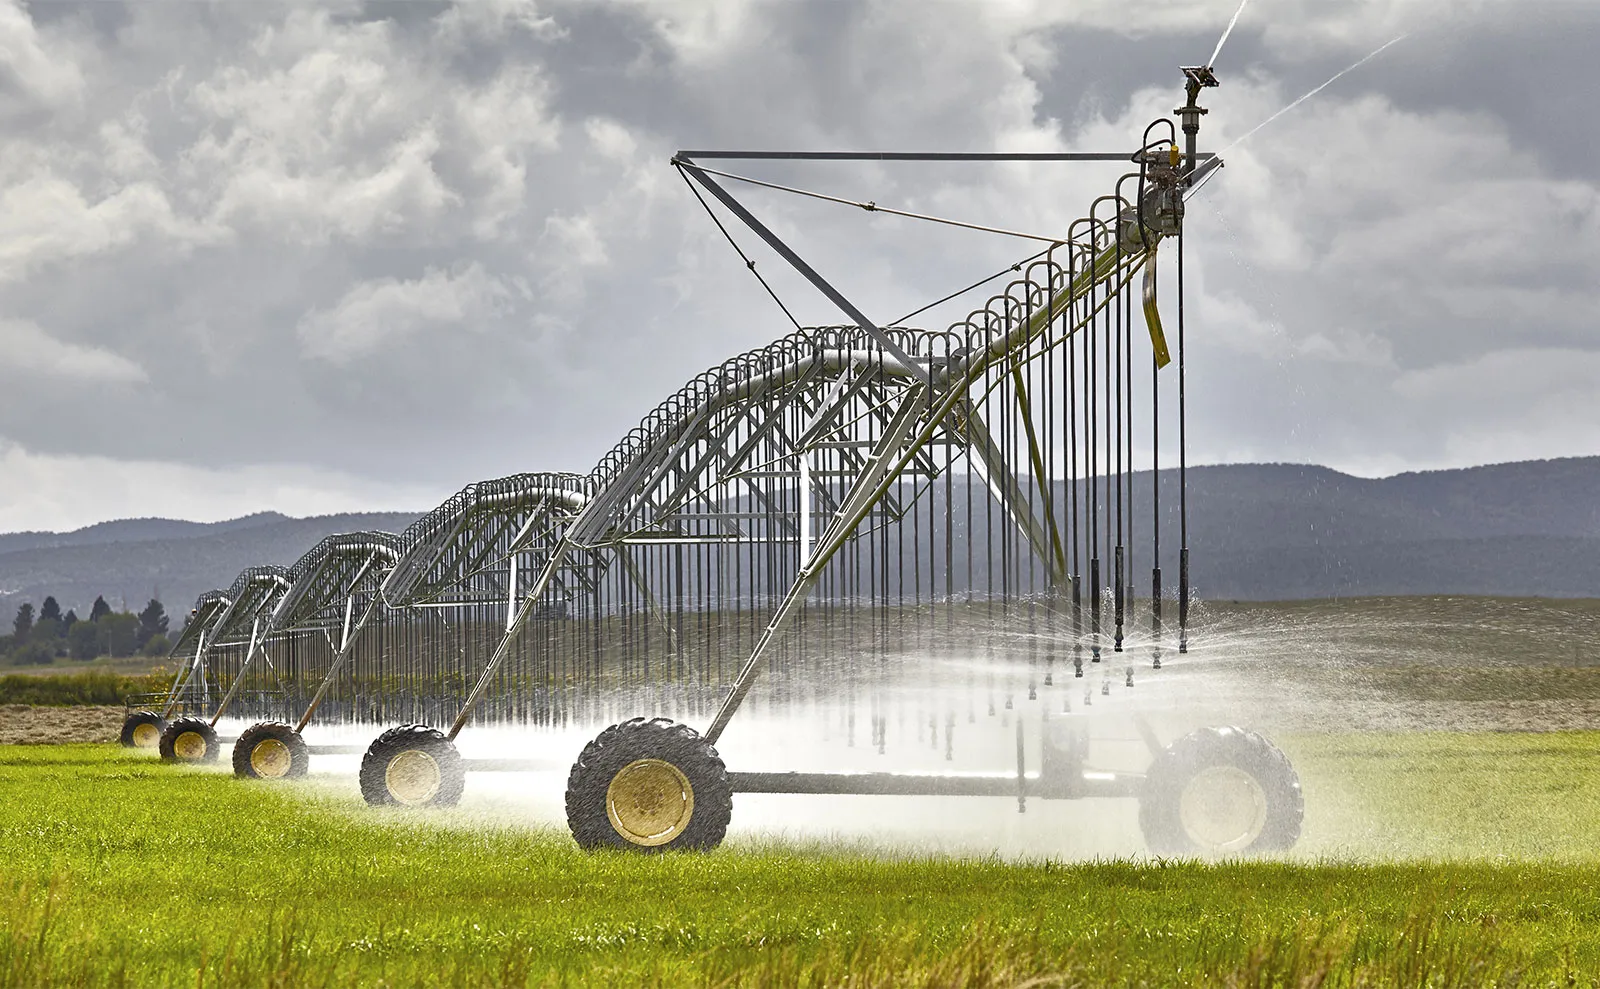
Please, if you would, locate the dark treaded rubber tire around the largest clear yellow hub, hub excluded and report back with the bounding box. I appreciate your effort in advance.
[566,717,733,853]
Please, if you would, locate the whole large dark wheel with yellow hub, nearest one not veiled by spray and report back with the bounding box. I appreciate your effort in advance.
[566,717,733,851]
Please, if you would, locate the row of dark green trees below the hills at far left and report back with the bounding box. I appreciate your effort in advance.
[0,595,173,666]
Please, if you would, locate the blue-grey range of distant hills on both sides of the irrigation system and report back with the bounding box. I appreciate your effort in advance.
[0,458,1600,618]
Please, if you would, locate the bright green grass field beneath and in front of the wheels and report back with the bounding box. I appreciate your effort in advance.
[0,733,1600,986]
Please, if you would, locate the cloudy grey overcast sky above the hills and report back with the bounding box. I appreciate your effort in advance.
[0,0,1600,530]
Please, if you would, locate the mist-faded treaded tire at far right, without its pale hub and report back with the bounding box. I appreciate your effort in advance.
[1139,727,1306,856]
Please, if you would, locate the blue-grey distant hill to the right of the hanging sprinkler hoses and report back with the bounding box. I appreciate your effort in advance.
[1136,458,1600,600]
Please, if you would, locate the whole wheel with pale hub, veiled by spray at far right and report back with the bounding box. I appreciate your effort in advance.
[1139,728,1306,855]
